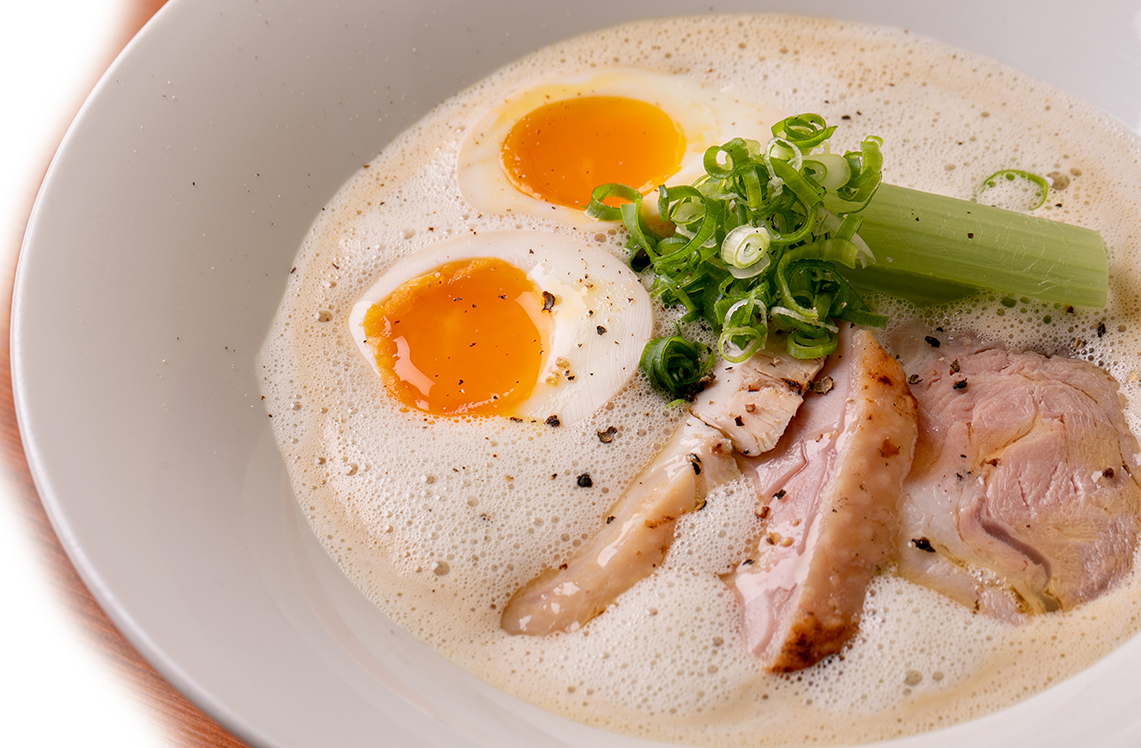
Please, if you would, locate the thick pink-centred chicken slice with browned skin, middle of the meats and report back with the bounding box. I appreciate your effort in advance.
[727,326,916,673]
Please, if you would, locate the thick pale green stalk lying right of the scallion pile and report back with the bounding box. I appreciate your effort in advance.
[843,185,1109,307]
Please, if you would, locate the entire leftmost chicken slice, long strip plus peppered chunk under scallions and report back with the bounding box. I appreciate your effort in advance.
[501,339,824,635]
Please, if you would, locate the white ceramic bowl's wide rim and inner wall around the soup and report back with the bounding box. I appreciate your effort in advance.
[11,0,1141,748]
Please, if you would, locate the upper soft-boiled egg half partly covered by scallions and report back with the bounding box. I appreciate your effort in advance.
[458,67,782,225]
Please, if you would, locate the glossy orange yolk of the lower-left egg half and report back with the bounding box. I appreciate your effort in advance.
[364,258,551,415]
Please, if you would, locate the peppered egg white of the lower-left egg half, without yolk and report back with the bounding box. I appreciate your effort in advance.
[348,230,653,423]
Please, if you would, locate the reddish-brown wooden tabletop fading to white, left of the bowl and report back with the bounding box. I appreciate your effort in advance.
[0,0,249,748]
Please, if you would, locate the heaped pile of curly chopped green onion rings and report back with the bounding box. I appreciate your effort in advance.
[588,114,885,361]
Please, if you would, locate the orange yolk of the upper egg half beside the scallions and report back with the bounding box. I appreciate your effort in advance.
[500,96,686,209]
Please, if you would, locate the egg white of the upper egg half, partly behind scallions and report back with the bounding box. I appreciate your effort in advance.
[458,67,784,226]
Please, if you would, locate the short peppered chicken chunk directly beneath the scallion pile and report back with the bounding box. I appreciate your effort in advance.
[693,336,824,456]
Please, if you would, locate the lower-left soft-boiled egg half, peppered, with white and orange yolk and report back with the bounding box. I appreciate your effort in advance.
[349,230,652,423]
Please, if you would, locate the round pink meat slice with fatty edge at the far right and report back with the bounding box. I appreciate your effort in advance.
[898,339,1141,620]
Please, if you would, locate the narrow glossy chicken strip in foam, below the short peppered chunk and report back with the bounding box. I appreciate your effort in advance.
[500,417,741,636]
